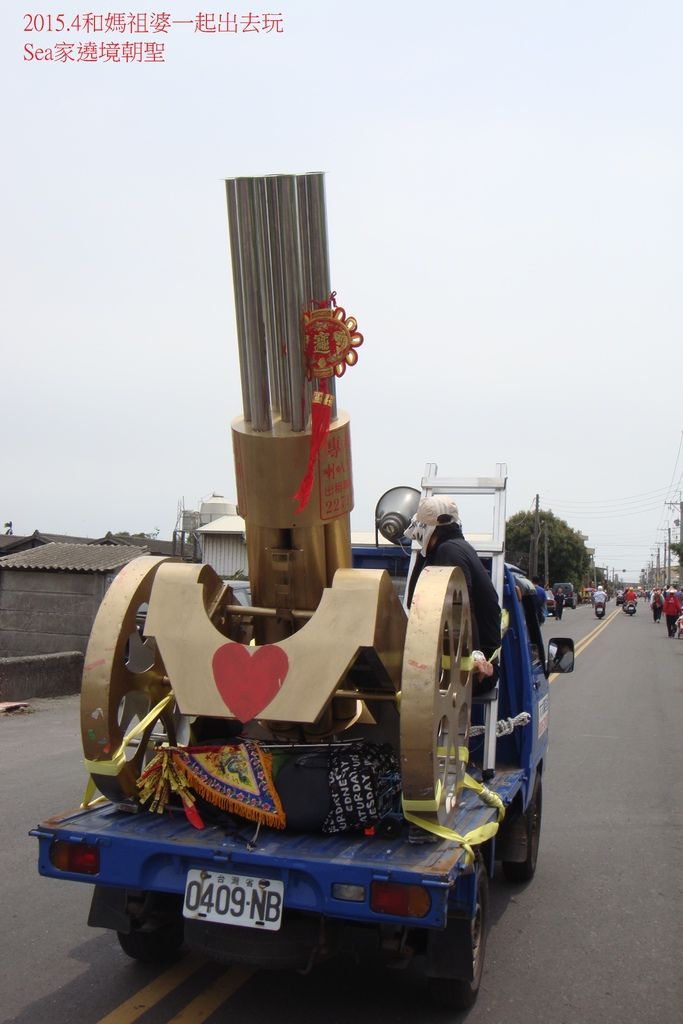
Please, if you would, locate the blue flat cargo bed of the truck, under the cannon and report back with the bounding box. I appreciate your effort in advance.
[31,769,523,927]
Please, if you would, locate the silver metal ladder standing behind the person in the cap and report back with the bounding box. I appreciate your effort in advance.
[403,462,508,778]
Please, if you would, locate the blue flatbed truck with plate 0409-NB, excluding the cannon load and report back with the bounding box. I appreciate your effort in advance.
[31,564,572,1009]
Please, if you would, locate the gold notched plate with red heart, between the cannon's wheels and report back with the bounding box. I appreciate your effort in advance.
[145,563,405,731]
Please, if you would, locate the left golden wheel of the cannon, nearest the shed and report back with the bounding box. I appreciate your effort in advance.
[81,555,178,801]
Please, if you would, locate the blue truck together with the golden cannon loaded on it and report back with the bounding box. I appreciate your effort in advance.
[32,172,572,1009]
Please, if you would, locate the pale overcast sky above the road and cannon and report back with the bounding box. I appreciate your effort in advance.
[0,0,683,578]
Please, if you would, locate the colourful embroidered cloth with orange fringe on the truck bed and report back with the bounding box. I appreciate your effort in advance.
[137,739,286,828]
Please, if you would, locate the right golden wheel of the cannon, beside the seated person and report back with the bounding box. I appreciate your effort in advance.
[400,566,472,825]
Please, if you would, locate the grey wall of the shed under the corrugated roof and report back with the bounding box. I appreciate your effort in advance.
[0,568,113,657]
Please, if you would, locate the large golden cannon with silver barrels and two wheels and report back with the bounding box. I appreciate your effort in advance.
[81,174,471,822]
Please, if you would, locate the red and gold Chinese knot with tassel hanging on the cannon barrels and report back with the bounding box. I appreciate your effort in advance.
[294,292,362,512]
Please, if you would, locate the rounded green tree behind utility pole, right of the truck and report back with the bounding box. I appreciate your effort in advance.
[505,510,591,590]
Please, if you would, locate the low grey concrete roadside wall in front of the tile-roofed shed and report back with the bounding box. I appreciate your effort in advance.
[0,650,83,700]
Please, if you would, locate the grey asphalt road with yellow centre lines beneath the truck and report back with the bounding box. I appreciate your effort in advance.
[0,603,683,1024]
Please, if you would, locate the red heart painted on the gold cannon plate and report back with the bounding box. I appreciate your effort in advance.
[212,643,290,722]
